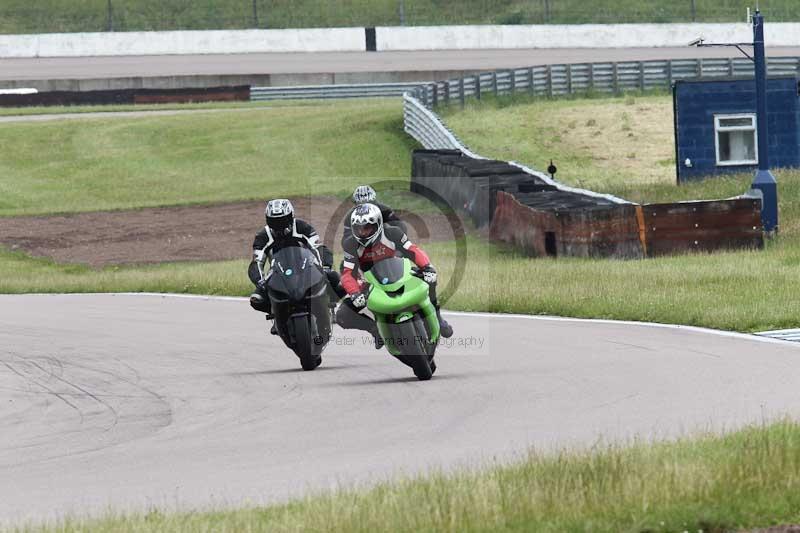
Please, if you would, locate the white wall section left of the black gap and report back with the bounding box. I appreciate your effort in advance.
[0,28,366,58]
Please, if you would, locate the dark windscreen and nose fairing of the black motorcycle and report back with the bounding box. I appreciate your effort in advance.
[267,246,325,301]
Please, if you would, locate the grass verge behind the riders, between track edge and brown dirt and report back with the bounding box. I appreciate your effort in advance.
[0,231,800,332]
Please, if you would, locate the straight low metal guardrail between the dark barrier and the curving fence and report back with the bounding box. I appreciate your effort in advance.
[250,82,420,101]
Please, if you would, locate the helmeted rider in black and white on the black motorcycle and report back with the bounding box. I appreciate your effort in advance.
[247,199,343,334]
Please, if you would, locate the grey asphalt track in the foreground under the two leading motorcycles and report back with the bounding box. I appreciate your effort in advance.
[0,295,800,525]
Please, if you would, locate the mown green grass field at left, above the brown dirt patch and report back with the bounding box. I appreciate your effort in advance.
[0,99,414,216]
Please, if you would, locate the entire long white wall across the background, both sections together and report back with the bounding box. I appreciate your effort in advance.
[0,23,800,58]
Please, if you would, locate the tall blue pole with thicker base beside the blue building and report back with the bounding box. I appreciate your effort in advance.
[753,10,778,233]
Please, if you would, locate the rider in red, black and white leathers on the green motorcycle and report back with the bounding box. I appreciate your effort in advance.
[336,203,453,349]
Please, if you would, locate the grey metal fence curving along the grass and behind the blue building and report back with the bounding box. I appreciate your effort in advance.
[412,57,800,108]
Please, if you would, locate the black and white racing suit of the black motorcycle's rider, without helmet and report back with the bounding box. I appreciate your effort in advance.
[247,218,343,314]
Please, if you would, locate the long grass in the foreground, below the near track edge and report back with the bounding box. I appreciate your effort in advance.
[18,421,800,533]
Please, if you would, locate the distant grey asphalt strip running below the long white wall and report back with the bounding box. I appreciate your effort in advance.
[0,47,800,80]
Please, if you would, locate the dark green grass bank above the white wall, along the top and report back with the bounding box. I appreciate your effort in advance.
[0,0,800,33]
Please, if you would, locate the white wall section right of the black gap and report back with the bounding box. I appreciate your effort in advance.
[377,23,800,51]
